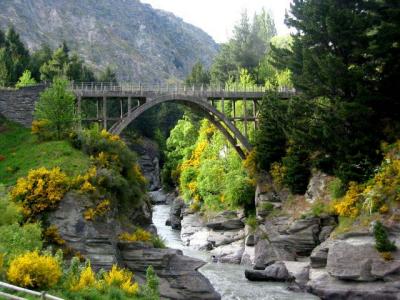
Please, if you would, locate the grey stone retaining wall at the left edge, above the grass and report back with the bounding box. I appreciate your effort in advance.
[0,85,45,127]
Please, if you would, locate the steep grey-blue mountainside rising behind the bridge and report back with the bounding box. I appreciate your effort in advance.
[0,0,218,82]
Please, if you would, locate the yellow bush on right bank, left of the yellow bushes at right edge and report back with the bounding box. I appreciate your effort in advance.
[333,182,363,217]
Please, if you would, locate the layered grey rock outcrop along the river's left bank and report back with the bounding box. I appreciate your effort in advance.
[48,192,220,300]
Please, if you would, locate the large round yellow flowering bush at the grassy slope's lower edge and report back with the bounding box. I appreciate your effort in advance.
[11,168,69,217]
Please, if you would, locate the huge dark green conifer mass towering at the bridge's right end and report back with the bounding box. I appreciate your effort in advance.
[262,0,400,182]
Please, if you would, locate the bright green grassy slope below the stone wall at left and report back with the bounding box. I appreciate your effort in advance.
[0,117,90,186]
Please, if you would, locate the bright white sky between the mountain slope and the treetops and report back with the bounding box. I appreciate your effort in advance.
[141,0,291,43]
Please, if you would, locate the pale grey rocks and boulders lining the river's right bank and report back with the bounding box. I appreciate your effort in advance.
[162,173,400,299]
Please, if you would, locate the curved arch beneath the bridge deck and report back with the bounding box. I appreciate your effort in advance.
[109,96,251,159]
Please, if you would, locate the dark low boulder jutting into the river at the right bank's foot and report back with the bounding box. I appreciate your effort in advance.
[245,261,293,281]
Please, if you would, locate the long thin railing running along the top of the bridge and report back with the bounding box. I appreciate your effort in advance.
[70,82,296,95]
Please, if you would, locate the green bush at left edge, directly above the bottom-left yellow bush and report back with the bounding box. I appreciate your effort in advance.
[0,223,43,264]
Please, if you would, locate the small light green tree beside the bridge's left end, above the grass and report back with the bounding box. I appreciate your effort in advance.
[34,78,77,139]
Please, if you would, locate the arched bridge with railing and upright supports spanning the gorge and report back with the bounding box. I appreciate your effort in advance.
[71,83,295,159]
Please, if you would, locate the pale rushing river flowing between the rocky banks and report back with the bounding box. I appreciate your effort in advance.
[153,205,318,300]
